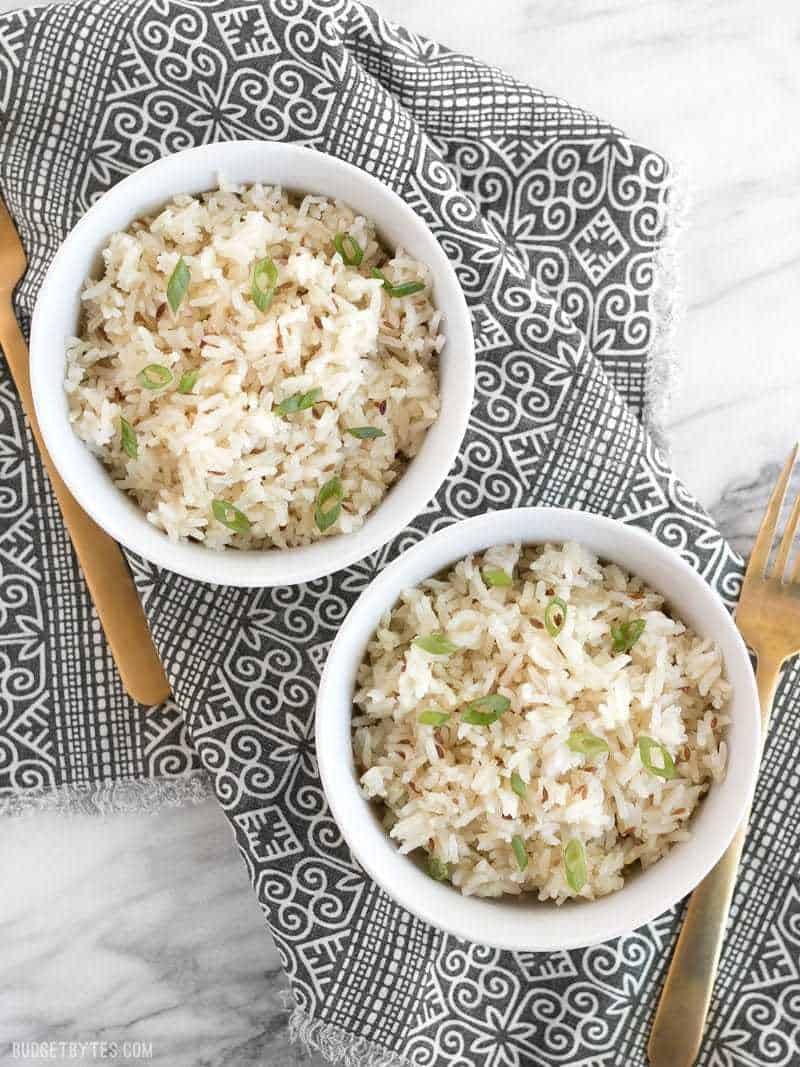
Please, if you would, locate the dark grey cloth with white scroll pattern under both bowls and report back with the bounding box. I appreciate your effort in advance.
[0,0,800,1067]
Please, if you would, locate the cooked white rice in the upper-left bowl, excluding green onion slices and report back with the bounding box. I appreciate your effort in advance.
[65,184,443,548]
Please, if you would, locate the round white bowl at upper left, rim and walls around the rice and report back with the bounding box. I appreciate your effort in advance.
[31,141,475,587]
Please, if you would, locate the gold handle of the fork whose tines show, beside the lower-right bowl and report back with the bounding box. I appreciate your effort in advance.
[647,658,782,1067]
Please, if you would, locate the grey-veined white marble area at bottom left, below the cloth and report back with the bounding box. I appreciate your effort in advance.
[0,801,308,1067]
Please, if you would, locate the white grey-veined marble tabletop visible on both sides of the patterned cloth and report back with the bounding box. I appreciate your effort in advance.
[0,0,800,1067]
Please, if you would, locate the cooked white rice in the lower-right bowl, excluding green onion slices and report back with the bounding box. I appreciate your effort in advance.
[353,543,730,903]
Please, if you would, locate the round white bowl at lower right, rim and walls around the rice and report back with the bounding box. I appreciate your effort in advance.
[317,508,761,952]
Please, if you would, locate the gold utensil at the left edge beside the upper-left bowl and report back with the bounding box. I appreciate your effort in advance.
[0,200,170,705]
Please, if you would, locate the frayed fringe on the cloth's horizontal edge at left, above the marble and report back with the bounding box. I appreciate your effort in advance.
[0,770,213,817]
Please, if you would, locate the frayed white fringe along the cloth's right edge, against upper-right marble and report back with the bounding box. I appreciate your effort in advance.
[643,166,690,455]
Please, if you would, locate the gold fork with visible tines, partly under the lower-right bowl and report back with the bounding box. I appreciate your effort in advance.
[647,445,800,1067]
